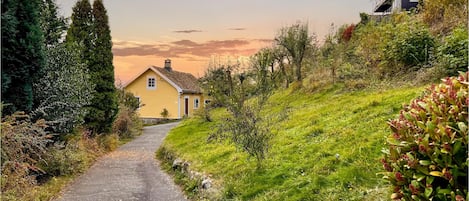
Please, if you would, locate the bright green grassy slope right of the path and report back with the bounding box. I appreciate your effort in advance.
[157,86,423,200]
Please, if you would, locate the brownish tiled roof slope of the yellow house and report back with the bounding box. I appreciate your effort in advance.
[152,66,202,93]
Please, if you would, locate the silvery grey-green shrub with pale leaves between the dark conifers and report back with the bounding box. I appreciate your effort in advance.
[32,44,94,133]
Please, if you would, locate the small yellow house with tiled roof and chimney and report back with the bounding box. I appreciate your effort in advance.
[124,59,204,120]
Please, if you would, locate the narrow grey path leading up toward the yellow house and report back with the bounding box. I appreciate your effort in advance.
[58,123,185,201]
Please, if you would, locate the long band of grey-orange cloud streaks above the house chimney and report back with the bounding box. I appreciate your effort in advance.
[113,39,266,59]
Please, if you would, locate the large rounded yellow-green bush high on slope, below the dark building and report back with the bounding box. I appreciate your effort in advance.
[352,13,435,77]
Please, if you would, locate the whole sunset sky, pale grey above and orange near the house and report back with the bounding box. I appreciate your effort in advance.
[57,0,374,83]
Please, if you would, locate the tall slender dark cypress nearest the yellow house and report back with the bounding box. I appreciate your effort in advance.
[85,0,118,133]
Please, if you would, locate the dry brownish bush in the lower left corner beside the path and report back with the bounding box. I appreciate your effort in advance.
[1,112,51,198]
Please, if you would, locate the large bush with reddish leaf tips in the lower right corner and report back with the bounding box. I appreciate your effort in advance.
[381,72,469,200]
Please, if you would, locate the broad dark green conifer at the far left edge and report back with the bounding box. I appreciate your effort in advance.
[1,0,44,114]
